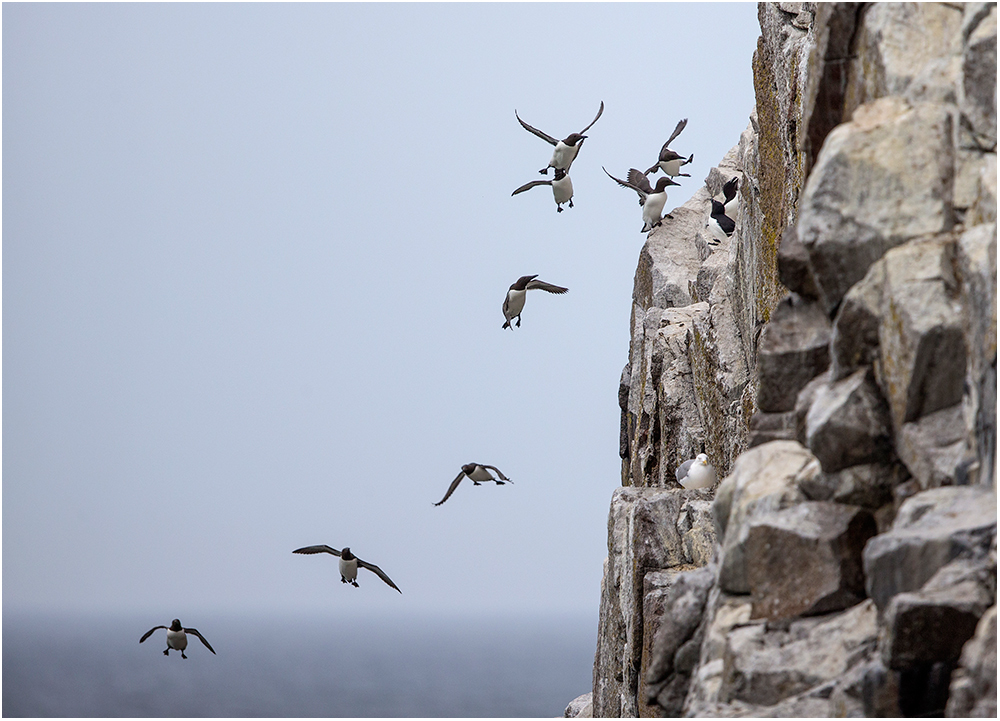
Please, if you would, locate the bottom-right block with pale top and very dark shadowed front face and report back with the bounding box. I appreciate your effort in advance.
[879,559,996,670]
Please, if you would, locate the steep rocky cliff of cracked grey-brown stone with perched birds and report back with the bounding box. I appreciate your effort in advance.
[580,3,997,716]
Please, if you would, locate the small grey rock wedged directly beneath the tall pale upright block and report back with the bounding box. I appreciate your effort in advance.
[896,404,969,489]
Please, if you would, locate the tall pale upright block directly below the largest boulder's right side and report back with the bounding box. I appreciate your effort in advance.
[879,237,966,429]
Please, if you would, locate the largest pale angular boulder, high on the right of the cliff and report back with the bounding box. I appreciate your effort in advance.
[798,97,954,312]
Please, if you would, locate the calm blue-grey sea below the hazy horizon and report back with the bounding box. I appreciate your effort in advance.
[2,613,597,717]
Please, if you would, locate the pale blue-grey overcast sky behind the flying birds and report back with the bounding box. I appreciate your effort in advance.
[3,3,759,624]
